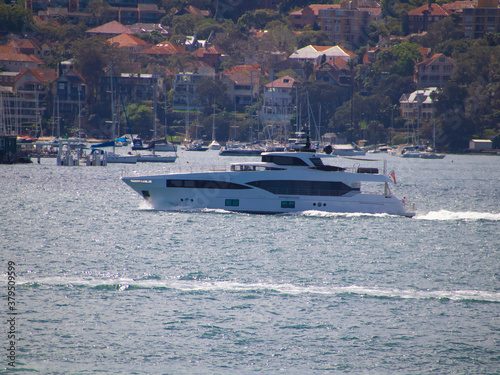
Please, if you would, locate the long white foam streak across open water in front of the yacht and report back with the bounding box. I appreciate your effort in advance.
[12,277,500,303]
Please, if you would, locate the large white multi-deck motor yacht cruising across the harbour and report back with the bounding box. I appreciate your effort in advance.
[122,152,414,217]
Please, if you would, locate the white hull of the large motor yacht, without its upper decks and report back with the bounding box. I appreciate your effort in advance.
[122,171,414,217]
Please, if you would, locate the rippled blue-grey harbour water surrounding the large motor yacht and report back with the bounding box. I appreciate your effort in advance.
[0,152,500,374]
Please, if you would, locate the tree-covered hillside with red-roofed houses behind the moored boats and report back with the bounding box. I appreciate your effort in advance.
[0,0,500,151]
